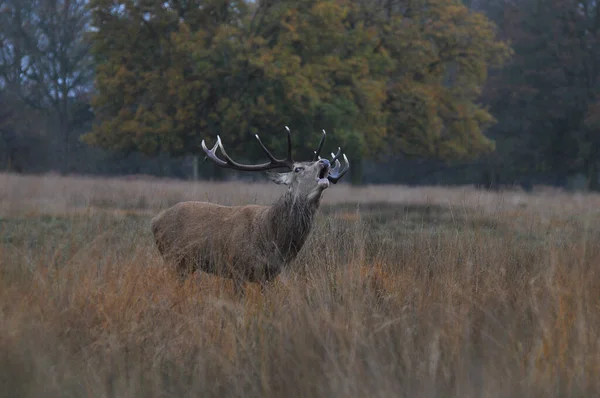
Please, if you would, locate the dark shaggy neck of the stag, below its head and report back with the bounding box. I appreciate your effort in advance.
[268,191,321,262]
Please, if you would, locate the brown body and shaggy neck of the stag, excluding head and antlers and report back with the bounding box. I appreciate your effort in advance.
[152,190,320,284]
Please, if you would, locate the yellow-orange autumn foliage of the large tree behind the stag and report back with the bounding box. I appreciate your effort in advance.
[86,0,509,165]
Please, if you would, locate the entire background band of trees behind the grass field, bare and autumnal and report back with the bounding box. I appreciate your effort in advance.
[0,0,600,189]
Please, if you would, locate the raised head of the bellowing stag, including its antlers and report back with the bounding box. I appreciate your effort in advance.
[202,126,350,202]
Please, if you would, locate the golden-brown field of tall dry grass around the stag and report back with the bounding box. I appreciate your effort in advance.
[0,174,600,397]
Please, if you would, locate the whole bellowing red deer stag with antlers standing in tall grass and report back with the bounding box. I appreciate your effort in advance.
[152,126,350,295]
